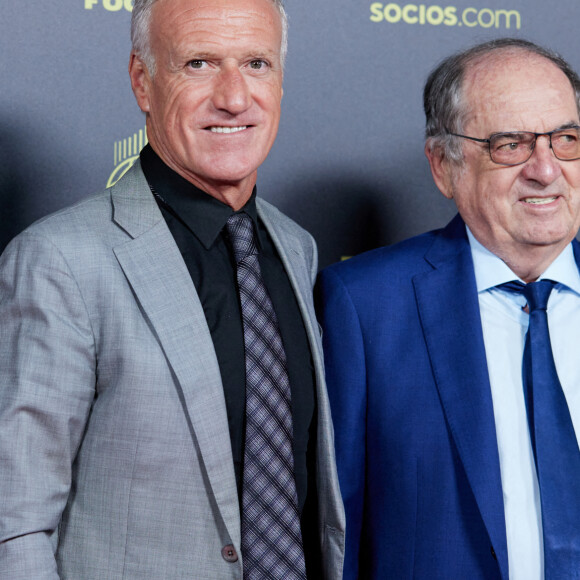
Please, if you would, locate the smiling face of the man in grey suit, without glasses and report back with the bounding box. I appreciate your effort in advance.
[129,0,282,204]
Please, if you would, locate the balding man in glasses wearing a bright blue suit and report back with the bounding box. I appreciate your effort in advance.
[319,39,580,580]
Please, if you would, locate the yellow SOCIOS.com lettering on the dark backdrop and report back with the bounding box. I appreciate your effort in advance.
[370,2,522,30]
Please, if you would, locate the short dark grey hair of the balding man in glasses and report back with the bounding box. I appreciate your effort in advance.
[423,38,580,165]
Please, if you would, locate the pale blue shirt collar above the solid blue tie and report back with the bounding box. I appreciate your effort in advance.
[465,226,580,294]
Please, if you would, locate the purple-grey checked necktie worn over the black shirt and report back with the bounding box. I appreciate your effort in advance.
[226,213,306,580]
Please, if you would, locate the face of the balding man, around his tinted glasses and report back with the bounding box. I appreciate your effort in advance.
[440,51,580,275]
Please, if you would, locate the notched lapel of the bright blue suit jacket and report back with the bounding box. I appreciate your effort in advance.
[413,217,508,579]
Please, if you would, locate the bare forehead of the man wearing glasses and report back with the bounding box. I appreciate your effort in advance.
[463,51,578,132]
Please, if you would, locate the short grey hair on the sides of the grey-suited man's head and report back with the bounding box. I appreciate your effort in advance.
[131,0,288,76]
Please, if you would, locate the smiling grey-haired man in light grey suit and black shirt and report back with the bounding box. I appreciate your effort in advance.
[0,0,344,580]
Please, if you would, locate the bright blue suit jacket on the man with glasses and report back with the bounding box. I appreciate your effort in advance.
[318,217,508,580]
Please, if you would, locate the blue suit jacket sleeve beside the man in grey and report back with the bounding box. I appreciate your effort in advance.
[315,269,367,580]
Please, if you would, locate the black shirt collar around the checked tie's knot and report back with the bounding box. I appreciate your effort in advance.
[140,144,261,249]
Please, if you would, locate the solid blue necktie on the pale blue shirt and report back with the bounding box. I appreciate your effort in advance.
[499,280,580,580]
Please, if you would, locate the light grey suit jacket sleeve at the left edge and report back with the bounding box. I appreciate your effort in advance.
[0,233,96,580]
